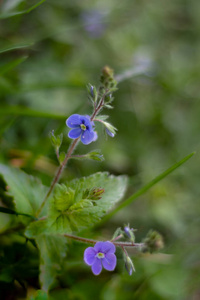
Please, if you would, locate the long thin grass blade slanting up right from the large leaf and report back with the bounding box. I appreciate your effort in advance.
[102,152,196,223]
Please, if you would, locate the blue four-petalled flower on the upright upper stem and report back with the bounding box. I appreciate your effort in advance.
[66,114,97,145]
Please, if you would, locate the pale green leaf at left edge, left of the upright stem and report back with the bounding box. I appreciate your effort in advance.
[0,164,47,216]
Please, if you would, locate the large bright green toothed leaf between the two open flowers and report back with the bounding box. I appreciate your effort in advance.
[25,173,127,238]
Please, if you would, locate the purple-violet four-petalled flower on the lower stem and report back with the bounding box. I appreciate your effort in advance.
[84,241,117,275]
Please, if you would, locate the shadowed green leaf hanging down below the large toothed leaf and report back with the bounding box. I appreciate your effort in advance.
[36,235,67,292]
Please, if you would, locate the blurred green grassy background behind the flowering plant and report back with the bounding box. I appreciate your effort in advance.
[0,0,200,300]
